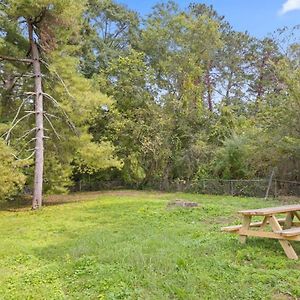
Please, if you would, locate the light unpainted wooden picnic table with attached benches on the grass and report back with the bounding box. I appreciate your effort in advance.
[222,204,300,259]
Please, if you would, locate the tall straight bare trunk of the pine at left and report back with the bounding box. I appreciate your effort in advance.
[28,22,44,209]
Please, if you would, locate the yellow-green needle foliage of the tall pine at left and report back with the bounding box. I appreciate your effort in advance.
[0,0,121,193]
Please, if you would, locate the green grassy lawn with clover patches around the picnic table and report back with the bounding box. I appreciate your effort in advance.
[0,191,300,299]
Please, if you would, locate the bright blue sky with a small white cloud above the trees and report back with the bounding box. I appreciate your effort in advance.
[116,0,300,38]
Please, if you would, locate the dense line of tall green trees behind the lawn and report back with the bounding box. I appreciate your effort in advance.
[0,0,300,208]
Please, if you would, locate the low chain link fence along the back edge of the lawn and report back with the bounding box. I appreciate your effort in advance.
[24,179,300,198]
